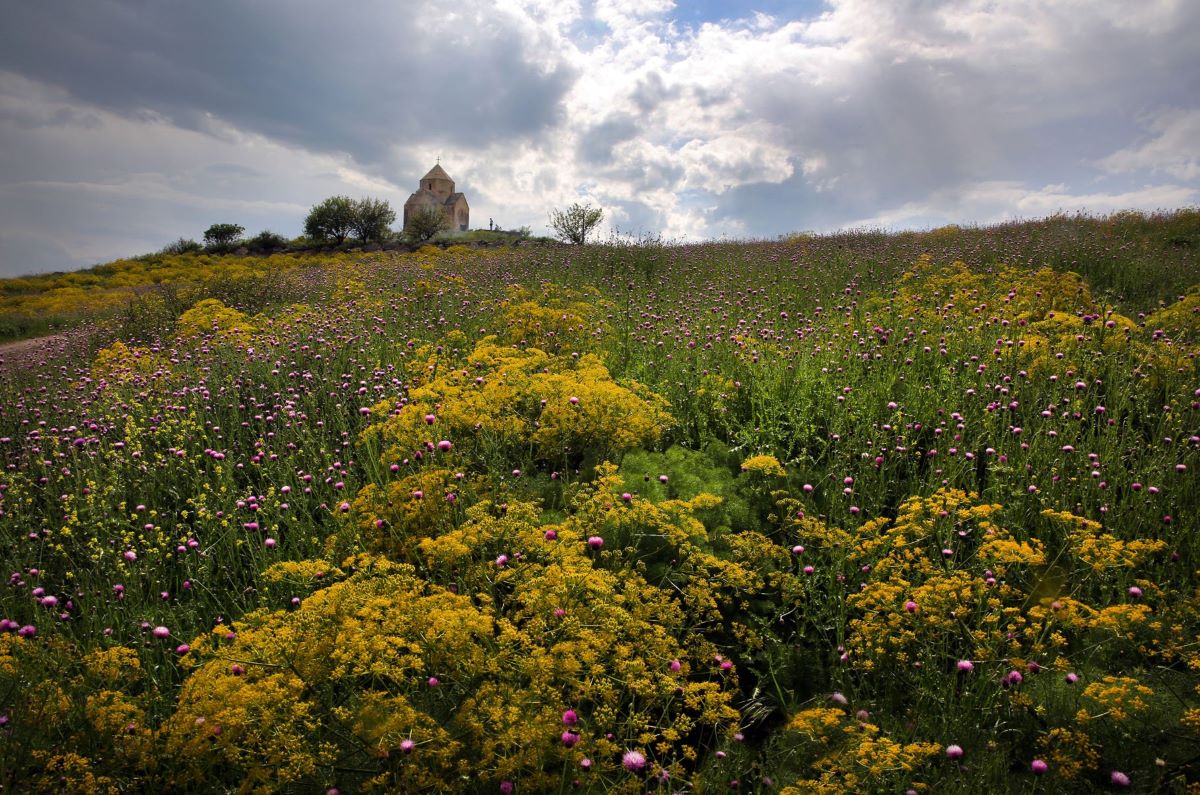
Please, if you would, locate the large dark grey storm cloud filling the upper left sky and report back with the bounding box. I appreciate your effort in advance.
[0,0,574,163]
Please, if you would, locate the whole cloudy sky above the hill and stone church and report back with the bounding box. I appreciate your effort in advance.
[0,0,1200,275]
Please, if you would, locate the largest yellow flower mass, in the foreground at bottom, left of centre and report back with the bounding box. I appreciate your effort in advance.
[163,475,734,793]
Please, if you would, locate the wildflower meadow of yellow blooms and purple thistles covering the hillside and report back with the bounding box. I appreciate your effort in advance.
[0,211,1200,793]
